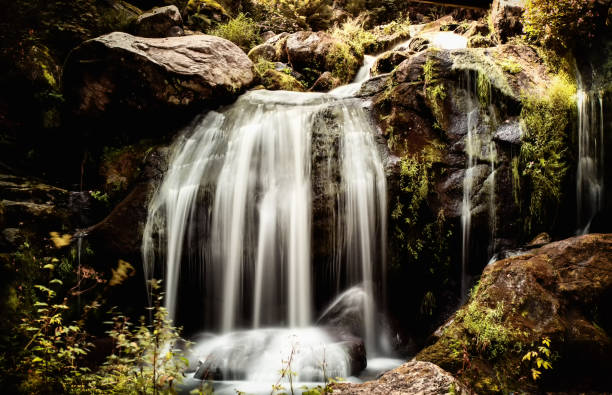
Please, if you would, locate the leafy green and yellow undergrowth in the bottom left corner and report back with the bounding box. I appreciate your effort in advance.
[0,241,186,394]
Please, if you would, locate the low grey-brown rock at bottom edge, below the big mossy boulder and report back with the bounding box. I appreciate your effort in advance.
[333,361,471,395]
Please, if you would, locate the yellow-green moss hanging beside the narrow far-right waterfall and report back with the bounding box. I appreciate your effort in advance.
[515,75,576,234]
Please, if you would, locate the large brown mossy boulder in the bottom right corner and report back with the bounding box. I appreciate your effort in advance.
[417,234,612,393]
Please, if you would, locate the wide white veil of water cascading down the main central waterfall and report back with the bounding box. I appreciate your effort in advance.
[143,51,387,388]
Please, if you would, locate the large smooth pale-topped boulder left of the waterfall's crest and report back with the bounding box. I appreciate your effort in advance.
[63,32,254,116]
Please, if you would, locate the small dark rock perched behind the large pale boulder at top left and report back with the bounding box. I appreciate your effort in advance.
[133,5,183,37]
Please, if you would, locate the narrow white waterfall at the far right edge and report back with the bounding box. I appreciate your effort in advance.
[576,72,604,234]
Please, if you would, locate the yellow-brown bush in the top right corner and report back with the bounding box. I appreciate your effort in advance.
[523,0,609,49]
